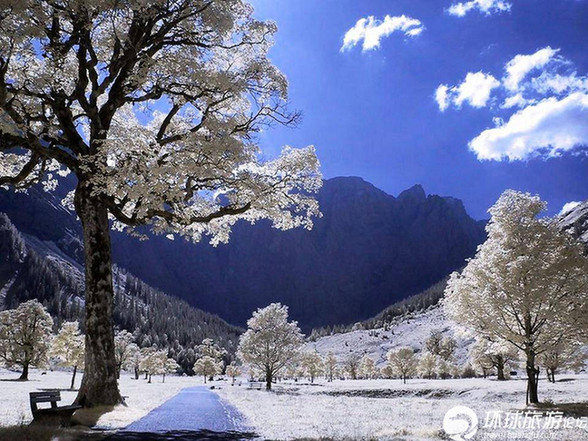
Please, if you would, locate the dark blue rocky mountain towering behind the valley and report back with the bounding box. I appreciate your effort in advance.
[0,177,485,330]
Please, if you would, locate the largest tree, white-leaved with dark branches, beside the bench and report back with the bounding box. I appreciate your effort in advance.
[0,0,321,406]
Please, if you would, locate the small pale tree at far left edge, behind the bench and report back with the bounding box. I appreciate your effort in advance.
[0,300,53,380]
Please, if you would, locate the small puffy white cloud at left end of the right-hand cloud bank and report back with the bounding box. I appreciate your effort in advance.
[435,72,500,111]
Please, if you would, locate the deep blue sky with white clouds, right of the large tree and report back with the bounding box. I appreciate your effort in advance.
[247,0,588,218]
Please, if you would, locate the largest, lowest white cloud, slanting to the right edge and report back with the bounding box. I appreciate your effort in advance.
[469,92,588,161]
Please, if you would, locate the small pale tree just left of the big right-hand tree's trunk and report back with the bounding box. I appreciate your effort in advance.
[470,338,519,380]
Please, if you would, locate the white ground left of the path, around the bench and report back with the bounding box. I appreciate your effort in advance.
[0,369,195,429]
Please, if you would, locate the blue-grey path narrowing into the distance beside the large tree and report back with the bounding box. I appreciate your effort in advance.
[108,386,251,441]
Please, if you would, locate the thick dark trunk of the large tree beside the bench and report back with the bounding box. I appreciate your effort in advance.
[74,179,122,407]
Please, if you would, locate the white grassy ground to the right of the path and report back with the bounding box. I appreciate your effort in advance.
[217,375,588,441]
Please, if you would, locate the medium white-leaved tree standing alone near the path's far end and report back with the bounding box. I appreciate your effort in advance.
[237,303,303,390]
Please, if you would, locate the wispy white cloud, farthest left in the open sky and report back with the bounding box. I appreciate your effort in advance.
[341,15,425,52]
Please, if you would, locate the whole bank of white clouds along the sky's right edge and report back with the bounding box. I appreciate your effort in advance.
[435,46,588,161]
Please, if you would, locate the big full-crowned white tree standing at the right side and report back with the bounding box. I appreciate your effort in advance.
[443,190,588,403]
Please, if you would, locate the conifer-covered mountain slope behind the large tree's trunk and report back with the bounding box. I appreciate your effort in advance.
[0,213,241,371]
